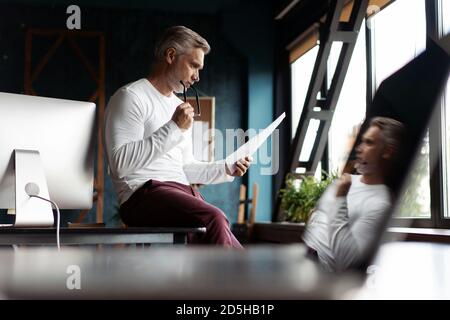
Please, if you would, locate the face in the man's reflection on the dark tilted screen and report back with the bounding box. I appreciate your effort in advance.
[355,126,385,174]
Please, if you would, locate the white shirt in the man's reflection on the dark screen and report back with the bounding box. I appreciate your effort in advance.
[303,175,391,271]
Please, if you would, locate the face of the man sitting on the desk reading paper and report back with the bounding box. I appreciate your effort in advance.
[168,48,205,93]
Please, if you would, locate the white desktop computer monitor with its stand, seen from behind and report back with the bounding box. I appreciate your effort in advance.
[0,92,95,227]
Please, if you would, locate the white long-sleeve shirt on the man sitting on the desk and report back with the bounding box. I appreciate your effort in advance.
[105,79,233,204]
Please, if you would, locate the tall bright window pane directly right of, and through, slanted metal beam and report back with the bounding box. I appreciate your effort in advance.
[328,21,367,173]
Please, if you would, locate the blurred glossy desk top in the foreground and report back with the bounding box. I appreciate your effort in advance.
[0,242,442,299]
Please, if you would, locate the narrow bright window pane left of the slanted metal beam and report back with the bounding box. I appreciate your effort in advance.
[291,46,319,138]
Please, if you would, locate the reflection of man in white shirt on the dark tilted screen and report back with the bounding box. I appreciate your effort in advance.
[303,117,405,271]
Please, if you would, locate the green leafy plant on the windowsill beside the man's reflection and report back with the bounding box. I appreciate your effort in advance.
[279,173,337,223]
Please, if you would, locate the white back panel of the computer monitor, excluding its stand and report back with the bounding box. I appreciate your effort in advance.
[0,92,95,209]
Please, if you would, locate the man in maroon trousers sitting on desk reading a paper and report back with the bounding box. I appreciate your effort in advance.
[105,26,250,248]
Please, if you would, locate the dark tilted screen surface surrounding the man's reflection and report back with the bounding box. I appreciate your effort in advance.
[346,35,450,270]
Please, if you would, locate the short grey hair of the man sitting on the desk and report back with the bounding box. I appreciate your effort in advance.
[155,26,211,61]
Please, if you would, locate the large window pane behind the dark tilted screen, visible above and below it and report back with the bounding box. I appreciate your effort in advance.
[370,0,431,218]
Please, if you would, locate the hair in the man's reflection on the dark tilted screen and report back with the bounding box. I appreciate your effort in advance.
[369,117,406,152]
